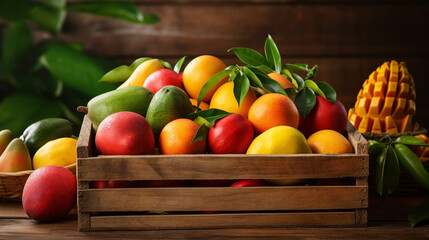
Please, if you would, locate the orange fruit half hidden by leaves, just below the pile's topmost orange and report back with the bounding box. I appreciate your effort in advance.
[210,82,256,118]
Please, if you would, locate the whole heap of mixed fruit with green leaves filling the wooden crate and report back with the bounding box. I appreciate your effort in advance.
[93,36,352,167]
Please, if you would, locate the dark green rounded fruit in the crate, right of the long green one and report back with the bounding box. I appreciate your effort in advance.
[146,86,194,139]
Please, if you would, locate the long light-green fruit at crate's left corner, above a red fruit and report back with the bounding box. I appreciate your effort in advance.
[88,86,153,130]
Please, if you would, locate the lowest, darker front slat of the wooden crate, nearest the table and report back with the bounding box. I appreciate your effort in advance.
[91,211,355,230]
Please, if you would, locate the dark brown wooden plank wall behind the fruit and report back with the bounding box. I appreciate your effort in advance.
[29,0,429,128]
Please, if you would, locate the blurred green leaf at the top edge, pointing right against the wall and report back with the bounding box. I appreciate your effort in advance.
[67,1,160,24]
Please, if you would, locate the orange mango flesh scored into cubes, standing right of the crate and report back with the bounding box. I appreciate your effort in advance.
[348,60,419,133]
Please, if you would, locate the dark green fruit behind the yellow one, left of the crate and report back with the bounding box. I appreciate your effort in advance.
[19,118,73,156]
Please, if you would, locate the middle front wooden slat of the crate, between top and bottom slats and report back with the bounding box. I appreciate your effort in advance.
[79,186,368,212]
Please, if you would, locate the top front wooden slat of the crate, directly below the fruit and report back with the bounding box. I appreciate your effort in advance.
[78,154,368,181]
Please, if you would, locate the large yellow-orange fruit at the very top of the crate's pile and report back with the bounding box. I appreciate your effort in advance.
[183,55,228,102]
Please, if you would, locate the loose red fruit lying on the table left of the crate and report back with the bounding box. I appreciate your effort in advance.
[22,165,77,221]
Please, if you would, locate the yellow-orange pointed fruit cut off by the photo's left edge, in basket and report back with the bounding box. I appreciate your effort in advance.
[0,138,32,172]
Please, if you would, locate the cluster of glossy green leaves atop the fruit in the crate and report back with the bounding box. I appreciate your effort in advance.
[197,35,337,118]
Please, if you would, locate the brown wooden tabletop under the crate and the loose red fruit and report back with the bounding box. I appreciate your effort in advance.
[0,202,429,240]
